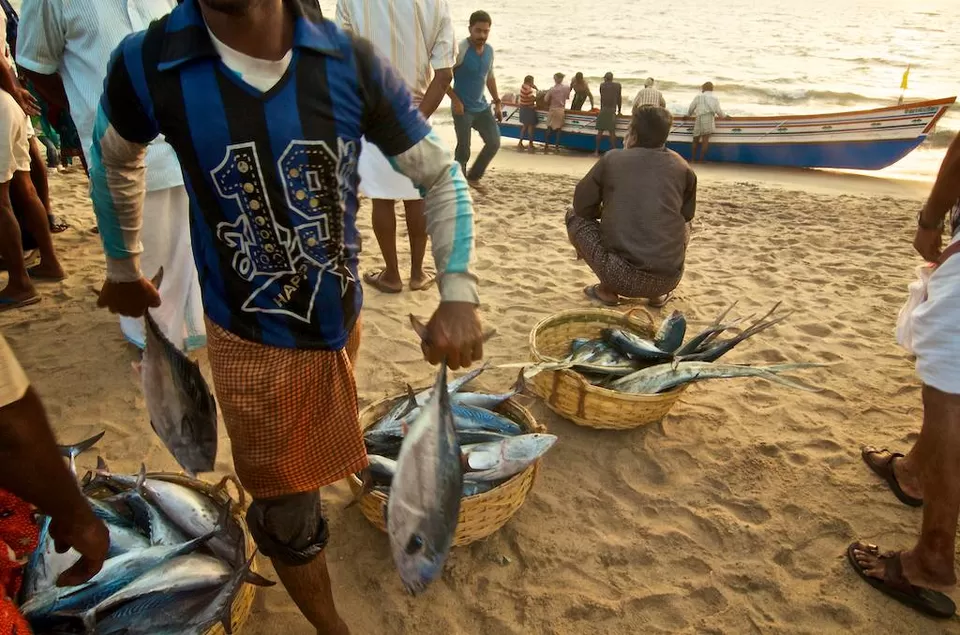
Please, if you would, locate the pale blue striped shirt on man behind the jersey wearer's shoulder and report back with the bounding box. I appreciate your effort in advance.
[17,0,183,191]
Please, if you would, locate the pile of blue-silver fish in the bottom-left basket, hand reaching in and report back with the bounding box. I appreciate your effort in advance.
[20,434,274,635]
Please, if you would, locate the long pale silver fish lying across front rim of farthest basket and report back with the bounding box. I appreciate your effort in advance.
[610,362,822,394]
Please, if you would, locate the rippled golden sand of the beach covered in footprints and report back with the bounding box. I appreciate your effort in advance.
[0,155,960,635]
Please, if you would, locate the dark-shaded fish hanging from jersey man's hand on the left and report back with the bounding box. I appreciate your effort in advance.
[139,268,217,476]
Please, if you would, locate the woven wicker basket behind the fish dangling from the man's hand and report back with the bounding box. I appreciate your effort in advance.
[349,397,547,547]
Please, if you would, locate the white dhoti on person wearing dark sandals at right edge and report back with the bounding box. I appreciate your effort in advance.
[913,236,960,395]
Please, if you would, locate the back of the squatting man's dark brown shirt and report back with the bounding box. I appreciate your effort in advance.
[600,148,697,275]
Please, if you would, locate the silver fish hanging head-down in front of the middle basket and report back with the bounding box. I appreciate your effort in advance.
[387,362,463,595]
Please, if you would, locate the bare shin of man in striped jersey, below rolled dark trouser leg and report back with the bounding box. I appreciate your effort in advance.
[273,552,350,635]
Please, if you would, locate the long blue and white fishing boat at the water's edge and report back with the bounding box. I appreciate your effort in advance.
[500,97,957,170]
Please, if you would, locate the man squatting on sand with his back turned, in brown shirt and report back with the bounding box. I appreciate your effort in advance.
[566,106,697,307]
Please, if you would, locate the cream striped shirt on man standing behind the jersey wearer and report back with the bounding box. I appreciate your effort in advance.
[337,0,457,99]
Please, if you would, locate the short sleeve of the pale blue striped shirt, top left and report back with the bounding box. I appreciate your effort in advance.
[16,0,66,75]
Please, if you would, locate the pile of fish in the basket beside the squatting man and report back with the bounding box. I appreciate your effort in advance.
[562,303,822,394]
